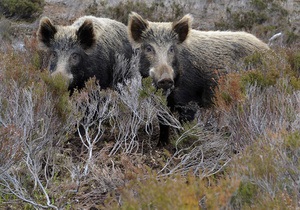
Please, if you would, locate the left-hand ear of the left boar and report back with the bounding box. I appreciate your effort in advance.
[37,17,57,47]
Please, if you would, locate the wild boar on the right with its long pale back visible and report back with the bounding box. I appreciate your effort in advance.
[128,12,269,145]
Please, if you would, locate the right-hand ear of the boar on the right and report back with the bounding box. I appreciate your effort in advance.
[172,15,193,43]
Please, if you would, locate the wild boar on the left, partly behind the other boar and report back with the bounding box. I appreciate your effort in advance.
[37,16,133,92]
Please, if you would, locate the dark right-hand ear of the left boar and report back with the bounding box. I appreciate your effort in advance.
[76,20,96,50]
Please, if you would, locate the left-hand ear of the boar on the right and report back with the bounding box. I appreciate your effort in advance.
[128,12,149,42]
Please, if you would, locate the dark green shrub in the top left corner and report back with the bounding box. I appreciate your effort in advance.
[0,0,44,19]
